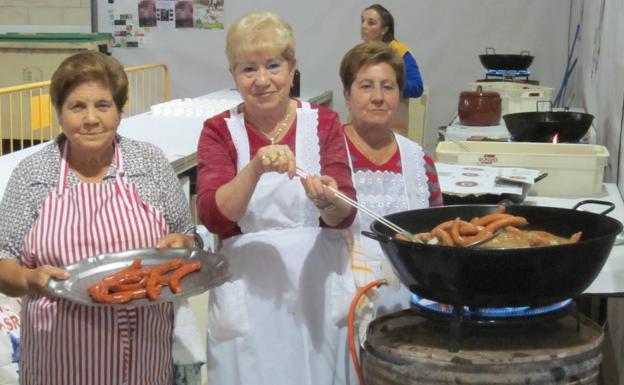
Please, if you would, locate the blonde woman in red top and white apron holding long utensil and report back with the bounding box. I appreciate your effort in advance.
[197,13,355,385]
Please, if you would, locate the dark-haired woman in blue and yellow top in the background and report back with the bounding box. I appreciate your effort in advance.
[360,4,423,98]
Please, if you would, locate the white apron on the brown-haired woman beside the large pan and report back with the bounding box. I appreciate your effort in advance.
[349,134,430,317]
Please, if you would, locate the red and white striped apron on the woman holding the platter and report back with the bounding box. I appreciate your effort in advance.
[20,142,173,385]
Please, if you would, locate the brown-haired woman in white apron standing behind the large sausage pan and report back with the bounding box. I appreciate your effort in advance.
[340,42,442,324]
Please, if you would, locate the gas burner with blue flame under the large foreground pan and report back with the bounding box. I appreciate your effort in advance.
[412,294,578,352]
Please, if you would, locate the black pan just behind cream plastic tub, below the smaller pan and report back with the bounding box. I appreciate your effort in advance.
[503,111,594,142]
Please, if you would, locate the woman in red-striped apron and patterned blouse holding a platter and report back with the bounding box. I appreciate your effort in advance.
[0,51,200,385]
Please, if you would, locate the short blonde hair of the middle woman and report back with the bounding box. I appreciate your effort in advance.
[225,12,295,68]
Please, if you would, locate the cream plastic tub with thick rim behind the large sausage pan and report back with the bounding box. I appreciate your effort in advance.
[436,141,609,197]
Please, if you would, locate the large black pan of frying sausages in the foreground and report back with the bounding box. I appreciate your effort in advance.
[363,201,622,307]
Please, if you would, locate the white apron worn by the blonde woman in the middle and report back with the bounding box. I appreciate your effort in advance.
[208,103,356,385]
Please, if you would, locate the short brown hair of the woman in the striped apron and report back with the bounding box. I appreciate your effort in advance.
[50,51,128,111]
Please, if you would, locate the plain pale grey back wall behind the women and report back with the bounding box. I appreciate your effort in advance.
[98,0,570,150]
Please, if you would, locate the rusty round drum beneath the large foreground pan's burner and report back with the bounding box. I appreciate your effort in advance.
[361,310,603,385]
